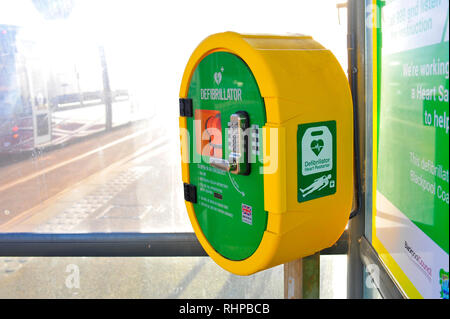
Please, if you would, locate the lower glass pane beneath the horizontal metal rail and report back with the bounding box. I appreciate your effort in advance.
[0,256,347,299]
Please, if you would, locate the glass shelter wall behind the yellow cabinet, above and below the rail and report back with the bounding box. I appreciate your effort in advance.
[0,0,347,298]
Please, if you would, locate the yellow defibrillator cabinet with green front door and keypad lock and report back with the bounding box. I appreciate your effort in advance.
[180,32,353,275]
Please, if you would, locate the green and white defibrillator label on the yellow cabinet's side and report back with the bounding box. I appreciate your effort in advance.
[297,121,336,202]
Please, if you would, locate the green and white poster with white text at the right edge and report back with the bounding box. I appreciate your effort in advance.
[375,0,449,298]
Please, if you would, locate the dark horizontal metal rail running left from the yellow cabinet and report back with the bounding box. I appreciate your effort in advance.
[0,233,207,257]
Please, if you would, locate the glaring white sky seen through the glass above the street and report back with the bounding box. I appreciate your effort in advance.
[0,0,347,125]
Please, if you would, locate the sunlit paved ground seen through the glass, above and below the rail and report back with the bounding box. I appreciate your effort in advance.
[0,120,346,299]
